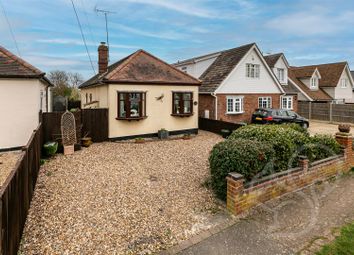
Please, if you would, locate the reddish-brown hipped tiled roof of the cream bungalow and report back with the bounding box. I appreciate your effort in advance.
[80,50,201,88]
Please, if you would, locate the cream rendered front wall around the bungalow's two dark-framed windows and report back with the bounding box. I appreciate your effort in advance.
[108,84,198,138]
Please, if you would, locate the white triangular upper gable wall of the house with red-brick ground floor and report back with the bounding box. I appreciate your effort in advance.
[216,49,282,94]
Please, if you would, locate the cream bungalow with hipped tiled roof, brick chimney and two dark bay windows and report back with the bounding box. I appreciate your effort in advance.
[79,43,201,140]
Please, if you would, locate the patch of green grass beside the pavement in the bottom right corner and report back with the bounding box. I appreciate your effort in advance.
[316,223,354,255]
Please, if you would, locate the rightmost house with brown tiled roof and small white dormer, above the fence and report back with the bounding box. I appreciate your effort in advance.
[289,62,354,103]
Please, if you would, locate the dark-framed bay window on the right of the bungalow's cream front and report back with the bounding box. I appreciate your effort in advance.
[172,92,193,116]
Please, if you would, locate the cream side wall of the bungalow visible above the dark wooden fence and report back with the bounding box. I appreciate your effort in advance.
[80,85,108,108]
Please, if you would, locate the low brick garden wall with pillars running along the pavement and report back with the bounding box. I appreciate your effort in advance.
[227,134,354,214]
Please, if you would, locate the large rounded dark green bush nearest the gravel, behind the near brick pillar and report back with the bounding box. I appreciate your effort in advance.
[209,139,275,200]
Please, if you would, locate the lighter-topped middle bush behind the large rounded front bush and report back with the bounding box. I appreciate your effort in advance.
[229,125,310,172]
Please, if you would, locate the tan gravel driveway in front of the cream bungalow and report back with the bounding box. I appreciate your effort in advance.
[21,131,222,254]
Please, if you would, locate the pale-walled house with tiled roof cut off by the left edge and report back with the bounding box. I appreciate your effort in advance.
[0,46,52,150]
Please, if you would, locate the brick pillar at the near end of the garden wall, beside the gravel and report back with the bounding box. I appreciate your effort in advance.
[226,173,245,215]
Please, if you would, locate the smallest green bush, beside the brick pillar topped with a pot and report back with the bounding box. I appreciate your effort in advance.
[300,135,341,161]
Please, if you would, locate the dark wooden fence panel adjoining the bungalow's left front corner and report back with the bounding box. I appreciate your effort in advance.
[81,109,108,142]
